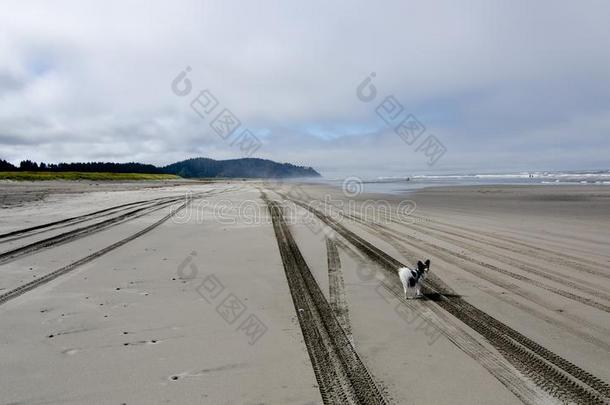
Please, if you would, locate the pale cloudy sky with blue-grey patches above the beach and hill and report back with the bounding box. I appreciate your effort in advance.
[0,0,610,177]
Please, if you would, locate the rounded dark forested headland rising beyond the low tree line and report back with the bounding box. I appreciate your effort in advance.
[162,158,320,178]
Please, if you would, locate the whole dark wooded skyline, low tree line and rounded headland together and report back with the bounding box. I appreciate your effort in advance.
[0,158,320,178]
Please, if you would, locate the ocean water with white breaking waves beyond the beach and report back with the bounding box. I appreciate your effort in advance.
[308,170,610,194]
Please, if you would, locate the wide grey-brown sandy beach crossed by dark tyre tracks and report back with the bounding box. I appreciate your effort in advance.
[0,181,610,404]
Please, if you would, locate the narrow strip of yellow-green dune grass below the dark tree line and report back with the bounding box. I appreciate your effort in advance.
[0,172,180,181]
